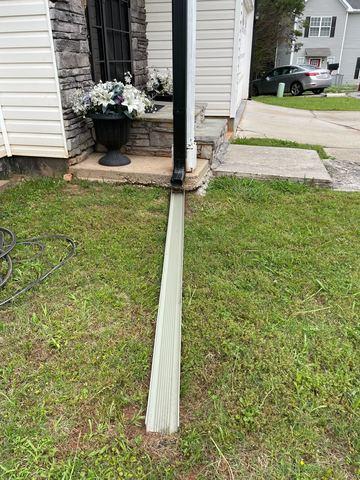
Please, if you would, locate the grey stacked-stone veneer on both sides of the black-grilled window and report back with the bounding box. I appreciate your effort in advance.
[49,0,148,163]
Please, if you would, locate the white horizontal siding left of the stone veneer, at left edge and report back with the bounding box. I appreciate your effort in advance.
[0,0,68,158]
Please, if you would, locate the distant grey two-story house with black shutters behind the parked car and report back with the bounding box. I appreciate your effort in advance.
[276,0,360,83]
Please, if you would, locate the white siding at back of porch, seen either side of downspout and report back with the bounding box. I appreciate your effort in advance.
[146,0,240,116]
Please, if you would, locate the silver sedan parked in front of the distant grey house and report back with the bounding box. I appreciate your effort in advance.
[251,65,331,96]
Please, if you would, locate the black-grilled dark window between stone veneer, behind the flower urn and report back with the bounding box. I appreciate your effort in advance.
[87,0,131,82]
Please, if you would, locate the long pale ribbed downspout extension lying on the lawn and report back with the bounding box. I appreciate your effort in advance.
[145,192,185,434]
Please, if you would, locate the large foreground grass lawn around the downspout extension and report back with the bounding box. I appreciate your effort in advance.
[0,178,360,480]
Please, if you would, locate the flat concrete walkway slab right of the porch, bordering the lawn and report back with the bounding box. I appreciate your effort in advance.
[214,145,332,187]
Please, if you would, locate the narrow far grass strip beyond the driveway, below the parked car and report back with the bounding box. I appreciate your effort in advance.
[254,95,360,111]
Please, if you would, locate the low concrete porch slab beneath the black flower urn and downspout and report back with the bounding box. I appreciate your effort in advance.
[70,153,210,190]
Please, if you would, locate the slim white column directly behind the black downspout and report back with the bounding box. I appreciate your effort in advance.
[186,0,197,172]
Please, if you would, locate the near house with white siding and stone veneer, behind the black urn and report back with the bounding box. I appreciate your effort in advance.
[0,0,254,189]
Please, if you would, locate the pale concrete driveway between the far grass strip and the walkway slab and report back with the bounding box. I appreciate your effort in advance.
[237,100,360,149]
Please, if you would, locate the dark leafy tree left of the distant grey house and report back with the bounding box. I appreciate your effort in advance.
[252,0,305,76]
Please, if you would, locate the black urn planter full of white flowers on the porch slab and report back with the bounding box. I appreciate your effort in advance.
[72,73,152,167]
